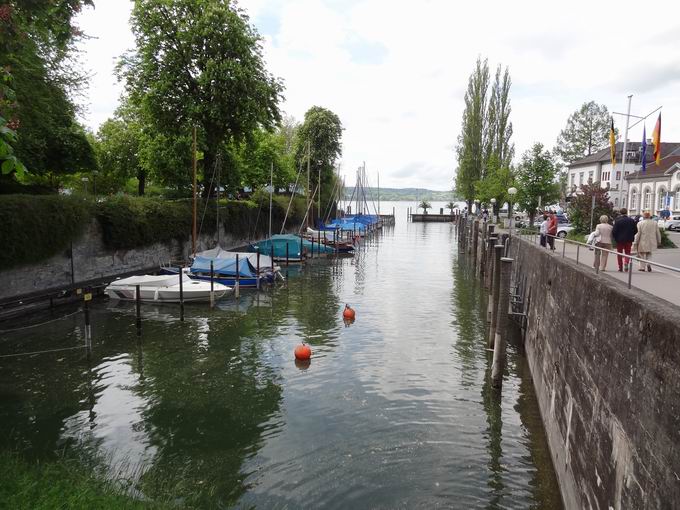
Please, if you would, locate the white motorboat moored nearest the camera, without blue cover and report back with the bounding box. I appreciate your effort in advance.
[104,274,232,303]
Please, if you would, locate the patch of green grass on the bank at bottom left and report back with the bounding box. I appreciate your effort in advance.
[0,452,172,510]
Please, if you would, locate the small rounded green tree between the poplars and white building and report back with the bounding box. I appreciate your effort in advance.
[516,143,559,225]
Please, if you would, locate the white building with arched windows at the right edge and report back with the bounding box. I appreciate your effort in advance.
[626,150,680,214]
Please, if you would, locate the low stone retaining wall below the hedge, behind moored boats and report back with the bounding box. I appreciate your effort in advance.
[0,220,258,300]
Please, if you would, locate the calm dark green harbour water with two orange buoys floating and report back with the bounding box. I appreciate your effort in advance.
[0,203,561,509]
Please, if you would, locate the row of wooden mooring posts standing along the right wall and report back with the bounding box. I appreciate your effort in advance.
[456,215,513,388]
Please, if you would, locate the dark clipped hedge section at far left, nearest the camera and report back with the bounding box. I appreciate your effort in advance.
[0,195,93,269]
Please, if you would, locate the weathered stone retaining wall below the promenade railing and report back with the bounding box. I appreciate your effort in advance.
[511,238,680,510]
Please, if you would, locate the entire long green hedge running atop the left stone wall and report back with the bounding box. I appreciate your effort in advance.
[0,195,305,268]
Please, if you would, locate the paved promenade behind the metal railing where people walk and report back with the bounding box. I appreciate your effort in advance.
[524,234,680,305]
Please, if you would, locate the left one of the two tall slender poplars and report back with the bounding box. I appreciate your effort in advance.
[456,57,489,210]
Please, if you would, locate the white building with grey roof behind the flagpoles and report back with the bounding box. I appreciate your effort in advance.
[567,140,680,209]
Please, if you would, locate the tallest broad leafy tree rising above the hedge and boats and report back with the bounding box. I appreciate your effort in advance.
[120,0,283,194]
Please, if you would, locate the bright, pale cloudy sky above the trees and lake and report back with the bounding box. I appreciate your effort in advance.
[77,0,680,190]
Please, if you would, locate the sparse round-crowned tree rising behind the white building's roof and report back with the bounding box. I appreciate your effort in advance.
[555,101,610,164]
